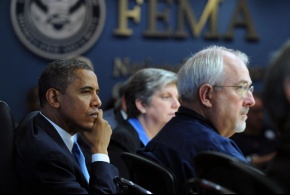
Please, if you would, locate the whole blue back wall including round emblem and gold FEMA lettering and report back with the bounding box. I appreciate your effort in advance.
[0,0,290,122]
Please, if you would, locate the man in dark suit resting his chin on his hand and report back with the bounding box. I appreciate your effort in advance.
[15,60,119,194]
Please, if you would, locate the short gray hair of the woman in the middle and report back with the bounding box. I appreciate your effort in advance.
[124,68,177,118]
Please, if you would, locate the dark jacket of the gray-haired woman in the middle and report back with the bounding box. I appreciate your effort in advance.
[108,121,144,179]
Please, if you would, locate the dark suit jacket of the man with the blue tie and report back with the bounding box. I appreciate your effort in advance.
[15,113,118,194]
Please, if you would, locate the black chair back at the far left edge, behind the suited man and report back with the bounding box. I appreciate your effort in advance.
[0,100,20,194]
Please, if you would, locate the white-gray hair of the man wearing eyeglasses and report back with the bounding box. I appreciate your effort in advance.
[178,45,249,103]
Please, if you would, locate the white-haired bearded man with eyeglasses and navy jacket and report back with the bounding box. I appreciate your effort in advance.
[137,45,255,193]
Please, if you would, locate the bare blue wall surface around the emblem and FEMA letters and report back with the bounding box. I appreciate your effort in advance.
[0,0,290,122]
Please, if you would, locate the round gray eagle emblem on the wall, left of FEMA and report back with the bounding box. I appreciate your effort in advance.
[11,0,105,59]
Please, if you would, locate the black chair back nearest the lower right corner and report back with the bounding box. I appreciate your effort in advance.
[195,151,284,194]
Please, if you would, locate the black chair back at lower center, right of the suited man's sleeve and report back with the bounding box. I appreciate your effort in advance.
[121,152,177,194]
